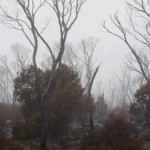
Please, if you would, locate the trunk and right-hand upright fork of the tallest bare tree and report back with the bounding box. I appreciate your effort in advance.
[41,0,87,149]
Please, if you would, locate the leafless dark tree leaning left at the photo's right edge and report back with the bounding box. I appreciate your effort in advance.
[102,0,150,84]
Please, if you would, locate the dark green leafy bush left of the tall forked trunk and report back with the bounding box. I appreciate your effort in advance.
[14,65,50,119]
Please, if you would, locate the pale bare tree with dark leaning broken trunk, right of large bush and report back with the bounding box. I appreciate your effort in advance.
[70,37,100,131]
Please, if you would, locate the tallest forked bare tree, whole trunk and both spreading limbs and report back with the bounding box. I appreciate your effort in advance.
[0,0,87,150]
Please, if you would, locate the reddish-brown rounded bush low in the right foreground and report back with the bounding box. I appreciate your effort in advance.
[81,114,143,150]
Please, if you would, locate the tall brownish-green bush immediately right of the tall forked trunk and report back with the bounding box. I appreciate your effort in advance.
[48,65,83,138]
